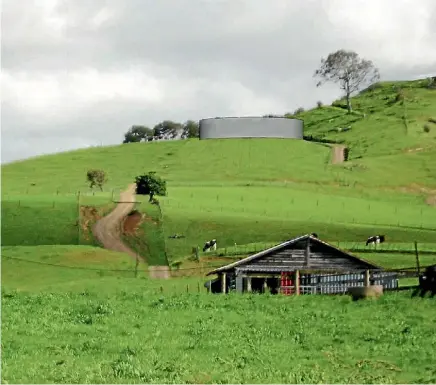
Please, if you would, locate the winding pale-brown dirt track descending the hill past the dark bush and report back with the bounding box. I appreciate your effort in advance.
[92,184,170,279]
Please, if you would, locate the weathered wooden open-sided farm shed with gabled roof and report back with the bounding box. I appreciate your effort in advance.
[205,234,398,295]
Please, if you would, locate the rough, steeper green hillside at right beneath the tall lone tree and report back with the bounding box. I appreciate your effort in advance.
[298,80,436,159]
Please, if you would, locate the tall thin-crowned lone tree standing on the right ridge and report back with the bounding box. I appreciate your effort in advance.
[314,49,380,112]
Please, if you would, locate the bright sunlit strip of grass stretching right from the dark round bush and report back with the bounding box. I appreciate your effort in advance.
[163,187,436,230]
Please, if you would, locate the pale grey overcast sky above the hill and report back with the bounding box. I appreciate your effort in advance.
[1,0,436,163]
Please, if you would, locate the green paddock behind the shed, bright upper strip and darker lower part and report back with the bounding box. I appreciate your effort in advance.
[161,186,436,261]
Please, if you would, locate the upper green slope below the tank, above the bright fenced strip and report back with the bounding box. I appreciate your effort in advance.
[2,81,436,194]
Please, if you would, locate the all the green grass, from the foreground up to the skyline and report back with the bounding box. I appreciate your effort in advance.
[1,81,436,383]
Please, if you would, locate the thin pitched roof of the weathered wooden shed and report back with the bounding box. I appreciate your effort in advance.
[206,234,382,275]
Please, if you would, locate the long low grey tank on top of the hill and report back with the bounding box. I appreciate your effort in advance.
[200,117,304,139]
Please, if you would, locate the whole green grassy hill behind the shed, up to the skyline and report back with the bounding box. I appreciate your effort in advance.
[2,81,436,261]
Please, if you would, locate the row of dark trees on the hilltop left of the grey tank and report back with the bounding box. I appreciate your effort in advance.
[123,120,199,143]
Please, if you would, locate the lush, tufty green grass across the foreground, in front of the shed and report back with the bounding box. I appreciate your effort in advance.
[2,284,436,383]
